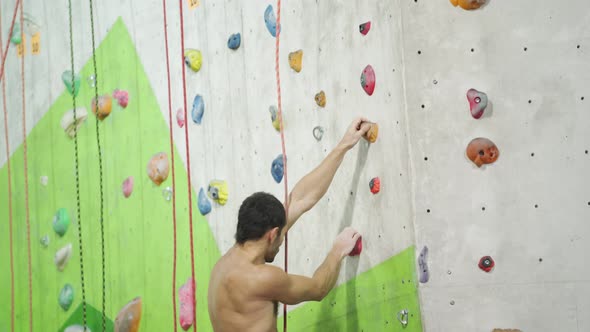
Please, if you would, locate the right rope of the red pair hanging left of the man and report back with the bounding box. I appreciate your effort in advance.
[178,0,197,332]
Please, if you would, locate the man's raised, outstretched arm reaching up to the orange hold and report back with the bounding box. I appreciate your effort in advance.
[284,118,371,232]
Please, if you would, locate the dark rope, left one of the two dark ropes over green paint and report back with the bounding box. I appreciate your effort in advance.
[68,0,86,329]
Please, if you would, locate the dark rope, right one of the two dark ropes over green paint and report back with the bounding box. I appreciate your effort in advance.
[89,0,106,332]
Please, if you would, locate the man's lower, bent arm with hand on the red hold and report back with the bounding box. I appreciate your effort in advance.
[259,228,360,304]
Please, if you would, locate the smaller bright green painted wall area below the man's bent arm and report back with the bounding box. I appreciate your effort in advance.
[278,246,422,332]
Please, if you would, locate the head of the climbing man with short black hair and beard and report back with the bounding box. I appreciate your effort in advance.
[236,192,287,263]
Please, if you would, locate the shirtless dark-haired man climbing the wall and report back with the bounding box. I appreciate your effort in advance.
[208,118,371,332]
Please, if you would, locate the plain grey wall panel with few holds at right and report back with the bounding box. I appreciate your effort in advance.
[401,0,590,332]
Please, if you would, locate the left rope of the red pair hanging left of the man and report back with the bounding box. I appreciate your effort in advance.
[162,0,177,332]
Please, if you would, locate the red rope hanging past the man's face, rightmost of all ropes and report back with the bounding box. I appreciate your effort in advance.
[275,0,289,332]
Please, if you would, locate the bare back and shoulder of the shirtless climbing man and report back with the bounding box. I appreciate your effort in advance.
[209,247,278,332]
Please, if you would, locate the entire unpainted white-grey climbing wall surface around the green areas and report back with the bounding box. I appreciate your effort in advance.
[0,0,590,332]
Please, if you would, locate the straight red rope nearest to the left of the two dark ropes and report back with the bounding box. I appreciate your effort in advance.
[20,1,33,332]
